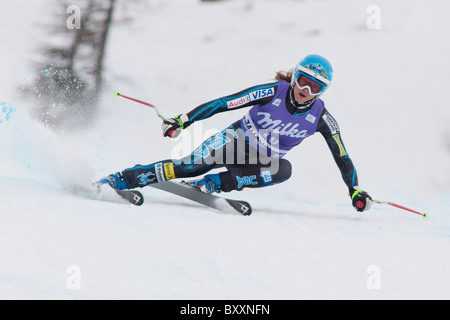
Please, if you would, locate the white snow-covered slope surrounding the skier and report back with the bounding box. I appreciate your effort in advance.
[0,0,450,299]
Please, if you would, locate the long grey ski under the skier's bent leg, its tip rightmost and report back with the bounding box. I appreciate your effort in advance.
[149,181,252,216]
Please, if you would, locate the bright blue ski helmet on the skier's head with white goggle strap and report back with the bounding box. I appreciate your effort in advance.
[291,54,333,94]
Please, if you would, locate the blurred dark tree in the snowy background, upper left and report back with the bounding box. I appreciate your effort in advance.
[24,0,116,128]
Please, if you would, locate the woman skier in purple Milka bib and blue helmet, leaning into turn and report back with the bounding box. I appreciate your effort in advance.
[97,55,372,212]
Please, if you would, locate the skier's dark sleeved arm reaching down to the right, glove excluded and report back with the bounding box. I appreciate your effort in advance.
[317,109,358,195]
